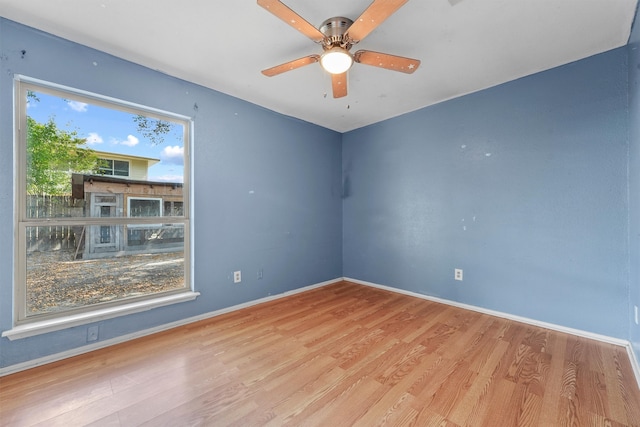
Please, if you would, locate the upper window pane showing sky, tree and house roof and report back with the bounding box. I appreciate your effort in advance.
[25,91,185,218]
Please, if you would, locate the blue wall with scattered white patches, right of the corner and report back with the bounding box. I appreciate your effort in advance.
[343,48,629,339]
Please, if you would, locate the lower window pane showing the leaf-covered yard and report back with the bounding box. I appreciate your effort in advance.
[26,225,185,317]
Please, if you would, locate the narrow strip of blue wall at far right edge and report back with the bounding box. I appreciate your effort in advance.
[627,5,640,360]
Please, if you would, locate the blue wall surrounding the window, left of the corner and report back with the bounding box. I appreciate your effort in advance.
[0,18,342,367]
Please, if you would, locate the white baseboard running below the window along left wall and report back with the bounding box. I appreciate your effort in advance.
[0,277,342,377]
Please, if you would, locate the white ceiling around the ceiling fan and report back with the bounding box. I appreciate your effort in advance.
[0,0,637,132]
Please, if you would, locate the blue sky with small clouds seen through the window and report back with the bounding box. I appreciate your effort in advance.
[27,92,184,182]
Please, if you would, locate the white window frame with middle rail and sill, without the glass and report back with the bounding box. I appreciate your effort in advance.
[2,75,199,340]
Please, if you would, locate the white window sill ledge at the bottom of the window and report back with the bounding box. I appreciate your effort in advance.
[2,291,200,341]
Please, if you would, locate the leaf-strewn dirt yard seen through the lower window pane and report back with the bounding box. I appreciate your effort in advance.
[27,251,184,315]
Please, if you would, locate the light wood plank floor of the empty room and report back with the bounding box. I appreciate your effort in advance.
[0,283,640,427]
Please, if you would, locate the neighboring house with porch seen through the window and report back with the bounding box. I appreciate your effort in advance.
[71,152,184,259]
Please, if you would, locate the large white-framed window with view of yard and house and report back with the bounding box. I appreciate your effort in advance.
[8,76,197,338]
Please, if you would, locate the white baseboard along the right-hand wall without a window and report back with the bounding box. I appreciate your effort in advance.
[344,277,640,387]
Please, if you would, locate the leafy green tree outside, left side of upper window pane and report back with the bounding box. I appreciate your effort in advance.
[27,116,98,196]
